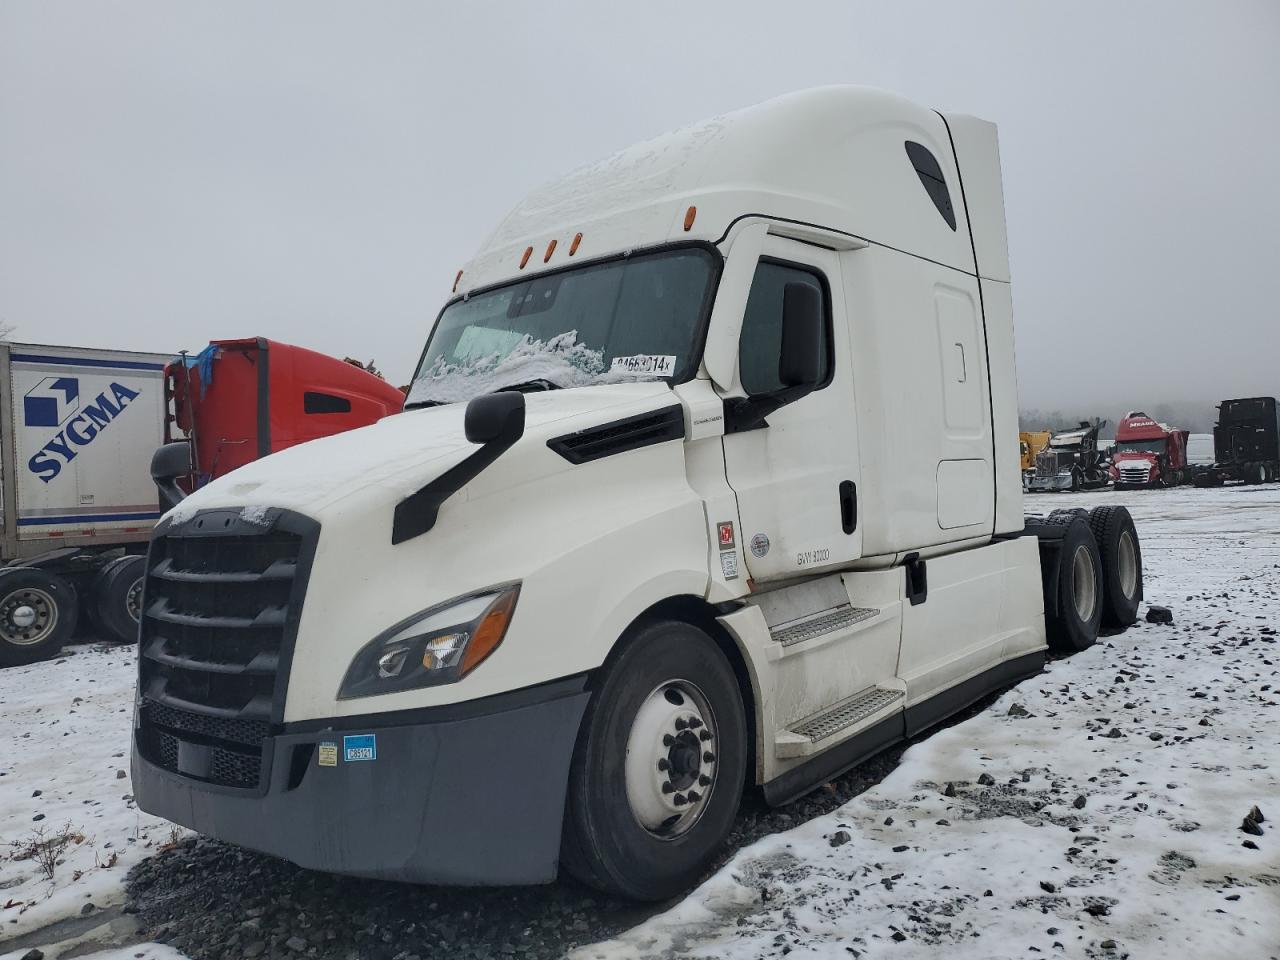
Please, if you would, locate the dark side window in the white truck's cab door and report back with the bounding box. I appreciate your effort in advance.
[737,260,832,397]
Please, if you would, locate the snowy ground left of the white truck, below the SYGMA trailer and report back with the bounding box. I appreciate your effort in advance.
[0,644,181,954]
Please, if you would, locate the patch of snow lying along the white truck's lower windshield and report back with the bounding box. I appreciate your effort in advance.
[408,330,658,404]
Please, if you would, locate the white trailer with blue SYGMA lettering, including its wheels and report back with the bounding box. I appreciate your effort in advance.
[0,342,169,666]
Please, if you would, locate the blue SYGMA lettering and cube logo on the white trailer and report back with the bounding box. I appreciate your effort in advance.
[22,376,138,484]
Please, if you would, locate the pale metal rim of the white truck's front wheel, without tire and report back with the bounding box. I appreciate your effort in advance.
[623,680,717,840]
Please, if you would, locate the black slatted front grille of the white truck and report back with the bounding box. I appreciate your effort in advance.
[138,511,316,788]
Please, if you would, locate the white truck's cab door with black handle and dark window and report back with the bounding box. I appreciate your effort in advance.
[723,236,863,581]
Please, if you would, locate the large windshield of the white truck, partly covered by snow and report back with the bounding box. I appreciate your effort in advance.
[407,247,716,406]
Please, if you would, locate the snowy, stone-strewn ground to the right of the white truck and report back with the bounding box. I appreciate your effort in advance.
[575,485,1280,960]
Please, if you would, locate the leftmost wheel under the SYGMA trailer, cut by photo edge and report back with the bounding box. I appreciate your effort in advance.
[0,567,79,667]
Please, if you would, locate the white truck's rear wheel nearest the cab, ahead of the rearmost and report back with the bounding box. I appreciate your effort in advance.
[1044,515,1103,653]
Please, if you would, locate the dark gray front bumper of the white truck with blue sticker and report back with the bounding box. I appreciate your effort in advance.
[132,676,589,884]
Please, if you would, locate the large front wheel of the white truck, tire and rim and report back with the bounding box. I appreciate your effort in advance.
[561,621,746,900]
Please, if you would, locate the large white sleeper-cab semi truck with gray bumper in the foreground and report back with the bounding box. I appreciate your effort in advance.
[133,87,1142,899]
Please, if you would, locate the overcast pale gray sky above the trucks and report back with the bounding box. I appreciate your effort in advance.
[0,0,1280,413]
